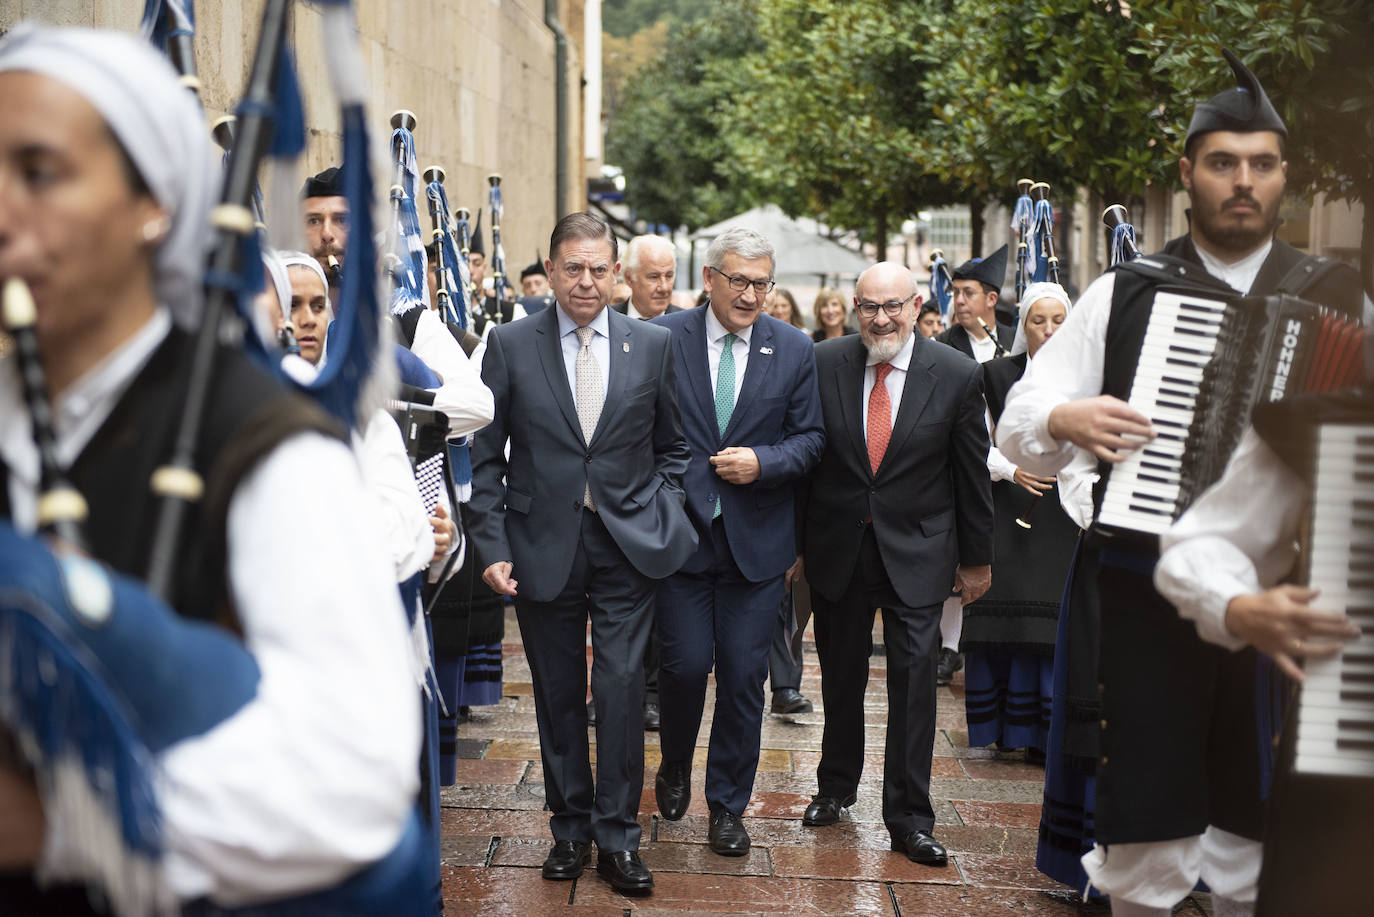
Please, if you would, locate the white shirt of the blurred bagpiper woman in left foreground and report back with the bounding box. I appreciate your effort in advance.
[0,311,420,906]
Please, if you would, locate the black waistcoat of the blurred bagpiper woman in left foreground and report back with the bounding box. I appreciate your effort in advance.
[0,329,342,621]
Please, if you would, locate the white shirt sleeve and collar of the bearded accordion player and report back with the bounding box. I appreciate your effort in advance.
[996,242,1272,474]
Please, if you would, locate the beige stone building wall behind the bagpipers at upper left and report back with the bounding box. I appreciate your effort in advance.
[0,0,585,269]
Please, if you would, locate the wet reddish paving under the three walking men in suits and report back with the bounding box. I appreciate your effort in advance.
[441,613,1210,917]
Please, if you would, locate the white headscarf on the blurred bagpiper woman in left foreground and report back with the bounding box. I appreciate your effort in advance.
[0,22,217,329]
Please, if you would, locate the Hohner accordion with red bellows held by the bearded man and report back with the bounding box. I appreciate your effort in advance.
[1098,290,1364,535]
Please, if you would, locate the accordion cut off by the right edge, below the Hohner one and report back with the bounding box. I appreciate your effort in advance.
[1256,406,1374,917]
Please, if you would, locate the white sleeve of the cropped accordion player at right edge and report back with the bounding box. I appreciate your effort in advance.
[1154,428,1311,650]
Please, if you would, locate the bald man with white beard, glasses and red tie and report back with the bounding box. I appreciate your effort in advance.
[802,261,992,866]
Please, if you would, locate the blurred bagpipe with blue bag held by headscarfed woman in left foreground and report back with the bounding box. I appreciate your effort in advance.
[0,0,436,917]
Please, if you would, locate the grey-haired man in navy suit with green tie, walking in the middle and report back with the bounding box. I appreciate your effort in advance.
[653,230,826,857]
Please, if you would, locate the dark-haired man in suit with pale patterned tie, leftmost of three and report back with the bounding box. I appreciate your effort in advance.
[471,213,697,892]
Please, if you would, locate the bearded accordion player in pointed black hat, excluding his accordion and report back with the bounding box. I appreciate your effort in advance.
[998,52,1360,917]
